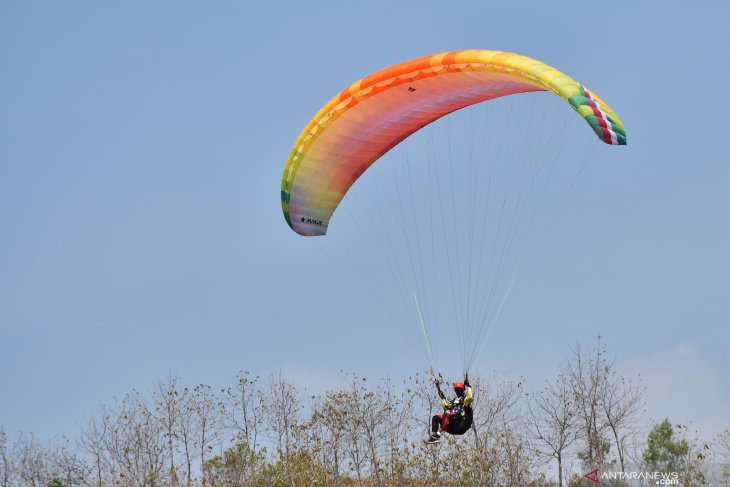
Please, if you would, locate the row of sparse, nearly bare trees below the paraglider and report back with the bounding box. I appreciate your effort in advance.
[0,341,730,487]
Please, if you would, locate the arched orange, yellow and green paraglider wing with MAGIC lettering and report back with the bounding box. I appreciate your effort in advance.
[281,50,626,235]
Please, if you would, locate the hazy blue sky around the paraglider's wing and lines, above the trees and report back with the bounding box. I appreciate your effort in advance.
[0,1,730,436]
